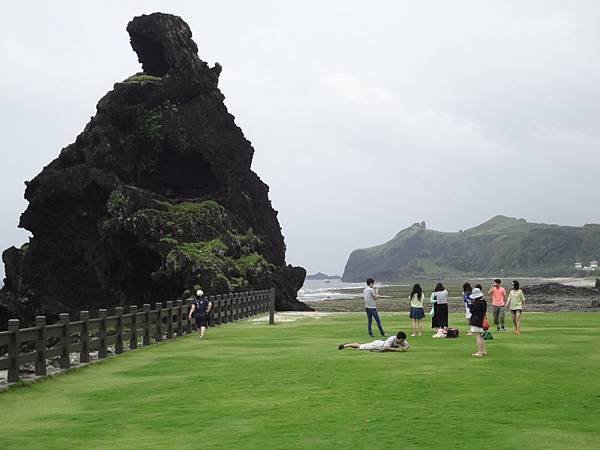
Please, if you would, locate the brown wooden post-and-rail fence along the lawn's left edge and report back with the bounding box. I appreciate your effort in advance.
[0,289,275,383]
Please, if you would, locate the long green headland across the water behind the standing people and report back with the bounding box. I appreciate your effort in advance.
[342,216,600,281]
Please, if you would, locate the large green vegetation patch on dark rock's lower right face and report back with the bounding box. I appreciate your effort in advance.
[100,187,274,293]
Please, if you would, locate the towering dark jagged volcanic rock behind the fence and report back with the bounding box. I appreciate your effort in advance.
[0,13,309,328]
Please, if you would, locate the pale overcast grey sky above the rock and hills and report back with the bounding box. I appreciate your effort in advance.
[0,0,600,282]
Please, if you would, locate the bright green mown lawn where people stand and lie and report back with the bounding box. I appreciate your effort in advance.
[0,313,600,449]
